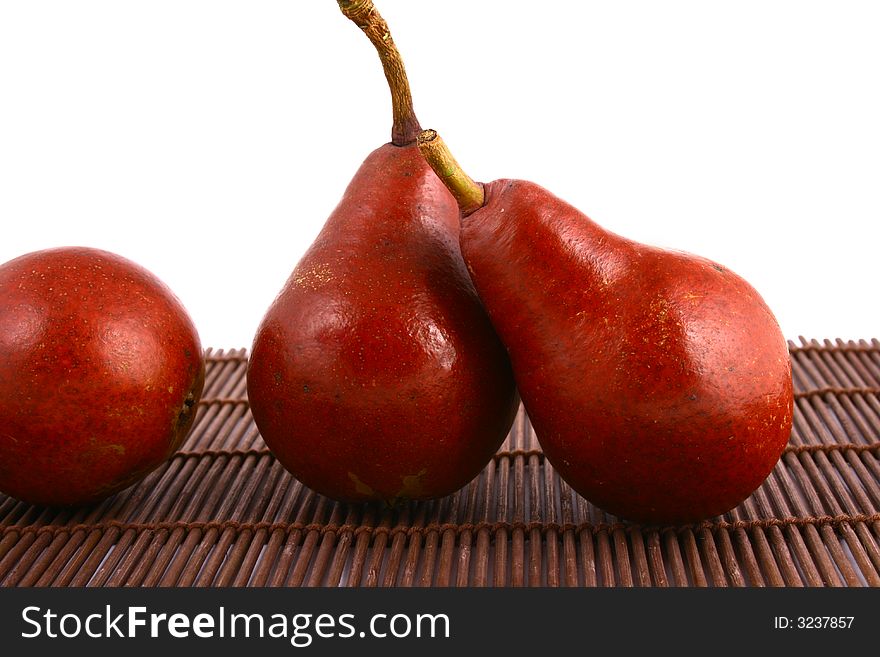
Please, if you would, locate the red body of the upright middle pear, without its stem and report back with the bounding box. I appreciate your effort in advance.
[248,144,519,502]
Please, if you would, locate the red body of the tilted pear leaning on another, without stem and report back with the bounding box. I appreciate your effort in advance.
[461,180,793,524]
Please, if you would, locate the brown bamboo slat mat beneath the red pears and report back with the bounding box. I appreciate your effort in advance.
[0,339,880,587]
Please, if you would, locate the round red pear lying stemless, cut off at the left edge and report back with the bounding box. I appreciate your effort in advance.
[0,247,205,506]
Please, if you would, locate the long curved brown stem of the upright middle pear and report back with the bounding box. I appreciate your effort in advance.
[336,0,422,146]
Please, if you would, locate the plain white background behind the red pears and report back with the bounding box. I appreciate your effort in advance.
[0,0,880,348]
